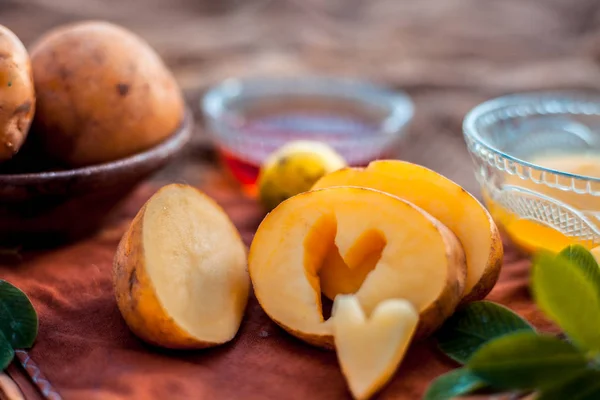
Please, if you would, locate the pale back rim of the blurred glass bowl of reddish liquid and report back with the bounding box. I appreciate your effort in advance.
[200,75,415,140]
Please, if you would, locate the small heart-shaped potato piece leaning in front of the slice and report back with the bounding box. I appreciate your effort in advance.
[331,295,419,400]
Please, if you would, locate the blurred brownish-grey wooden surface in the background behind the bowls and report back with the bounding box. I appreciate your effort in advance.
[0,0,600,192]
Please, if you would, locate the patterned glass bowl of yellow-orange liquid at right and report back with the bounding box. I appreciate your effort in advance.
[463,92,600,253]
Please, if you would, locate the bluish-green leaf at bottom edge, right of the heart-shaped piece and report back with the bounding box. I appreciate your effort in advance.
[423,368,487,400]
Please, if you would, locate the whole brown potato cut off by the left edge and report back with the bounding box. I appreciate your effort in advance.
[0,25,35,162]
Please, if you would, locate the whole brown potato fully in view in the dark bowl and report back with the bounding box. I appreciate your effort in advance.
[30,21,185,167]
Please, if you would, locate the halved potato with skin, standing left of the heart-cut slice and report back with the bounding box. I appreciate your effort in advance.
[113,184,250,348]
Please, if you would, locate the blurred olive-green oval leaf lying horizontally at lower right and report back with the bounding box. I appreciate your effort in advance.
[467,332,587,389]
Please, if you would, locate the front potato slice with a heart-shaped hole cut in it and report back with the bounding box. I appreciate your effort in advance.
[248,187,466,347]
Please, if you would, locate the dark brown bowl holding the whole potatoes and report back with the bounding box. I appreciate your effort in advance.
[0,111,193,248]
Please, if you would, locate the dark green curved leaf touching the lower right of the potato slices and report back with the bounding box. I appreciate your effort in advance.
[436,301,534,364]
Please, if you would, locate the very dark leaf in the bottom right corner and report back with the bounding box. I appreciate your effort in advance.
[536,369,600,400]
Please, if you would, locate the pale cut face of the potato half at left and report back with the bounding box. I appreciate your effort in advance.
[143,187,249,343]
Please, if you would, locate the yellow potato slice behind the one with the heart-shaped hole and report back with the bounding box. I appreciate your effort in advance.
[313,160,503,303]
